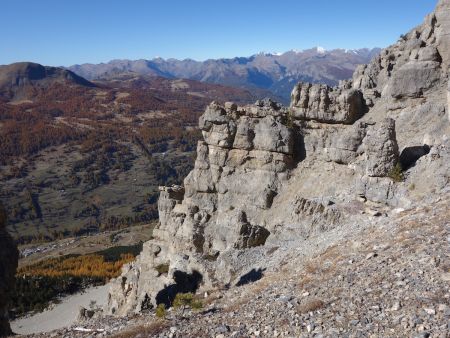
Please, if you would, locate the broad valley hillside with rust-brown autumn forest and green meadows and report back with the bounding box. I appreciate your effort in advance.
[0,67,254,243]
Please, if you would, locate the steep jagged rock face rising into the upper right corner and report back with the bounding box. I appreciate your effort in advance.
[353,0,450,104]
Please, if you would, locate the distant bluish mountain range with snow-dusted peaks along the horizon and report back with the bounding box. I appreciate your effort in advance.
[68,47,380,102]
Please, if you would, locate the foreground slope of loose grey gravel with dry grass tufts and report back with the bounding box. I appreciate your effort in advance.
[21,193,450,338]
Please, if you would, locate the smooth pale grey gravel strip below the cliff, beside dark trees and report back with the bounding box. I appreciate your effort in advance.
[11,285,108,334]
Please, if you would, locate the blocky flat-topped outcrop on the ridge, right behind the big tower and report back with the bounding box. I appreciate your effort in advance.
[291,83,366,124]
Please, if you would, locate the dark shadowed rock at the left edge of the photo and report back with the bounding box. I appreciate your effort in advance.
[0,205,19,337]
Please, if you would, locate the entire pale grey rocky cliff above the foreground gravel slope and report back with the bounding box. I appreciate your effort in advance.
[107,0,450,315]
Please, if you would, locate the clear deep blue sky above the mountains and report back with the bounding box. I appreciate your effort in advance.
[0,0,437,66]
